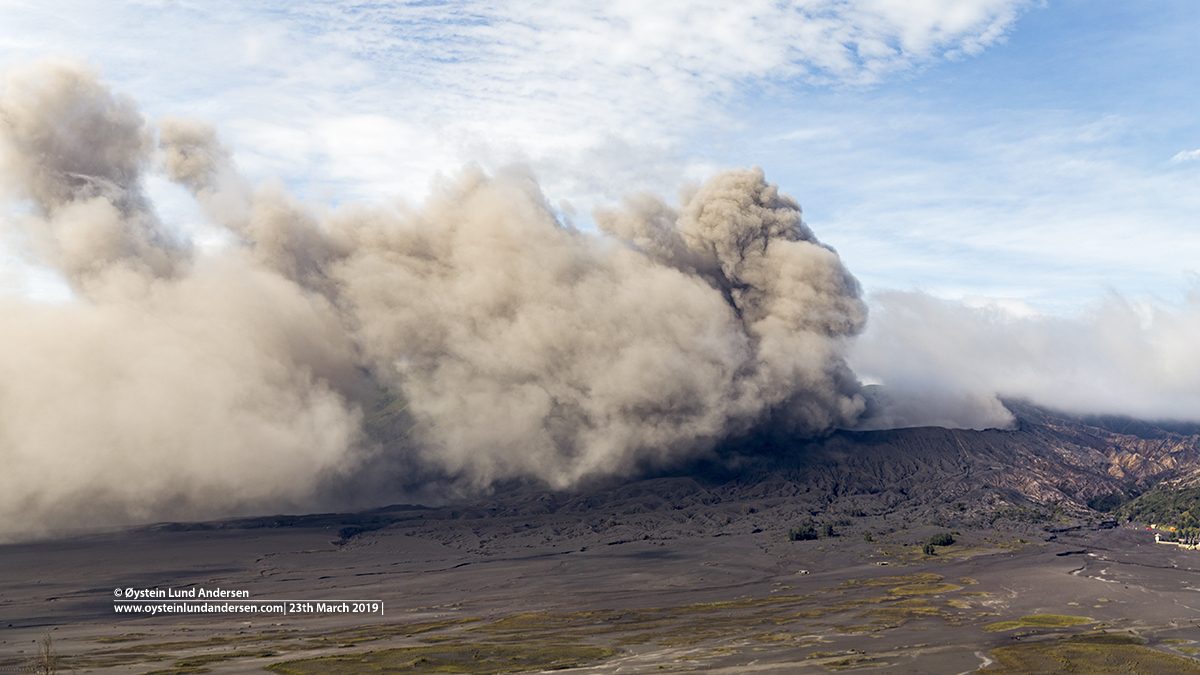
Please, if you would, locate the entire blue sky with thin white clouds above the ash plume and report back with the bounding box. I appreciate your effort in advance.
[0,0,1200,313]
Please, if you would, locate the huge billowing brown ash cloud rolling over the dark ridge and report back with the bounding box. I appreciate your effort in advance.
[0,61,865,532]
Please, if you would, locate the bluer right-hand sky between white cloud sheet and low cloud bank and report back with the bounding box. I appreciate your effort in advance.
[755,2,1200,312]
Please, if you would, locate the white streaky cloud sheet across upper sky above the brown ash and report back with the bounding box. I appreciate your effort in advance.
[0,0,1027,203]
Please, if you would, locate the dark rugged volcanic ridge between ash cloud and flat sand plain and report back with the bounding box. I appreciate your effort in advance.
[151,401,1200,555]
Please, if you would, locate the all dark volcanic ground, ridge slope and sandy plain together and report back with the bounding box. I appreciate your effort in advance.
[7,404,1200,674]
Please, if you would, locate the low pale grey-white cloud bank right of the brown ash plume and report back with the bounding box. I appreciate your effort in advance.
[850,292,1200,429]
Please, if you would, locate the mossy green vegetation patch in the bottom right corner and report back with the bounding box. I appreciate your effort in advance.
[976,634,1200,675]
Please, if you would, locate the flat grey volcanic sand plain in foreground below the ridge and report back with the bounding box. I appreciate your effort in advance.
[0,507,1200,675]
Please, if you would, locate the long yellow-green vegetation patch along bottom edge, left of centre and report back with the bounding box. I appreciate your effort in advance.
[266,644,619,675]
